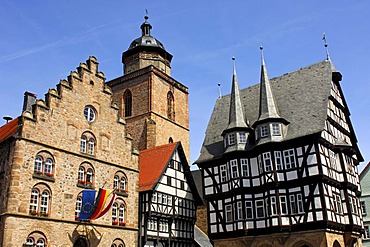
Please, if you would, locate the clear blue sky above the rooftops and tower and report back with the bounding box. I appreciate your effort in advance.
[0,0,370,171]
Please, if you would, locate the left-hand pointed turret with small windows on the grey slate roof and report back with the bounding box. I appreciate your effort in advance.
[222,57,252,152]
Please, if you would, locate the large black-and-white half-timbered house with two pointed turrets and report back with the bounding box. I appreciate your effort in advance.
[195,50,363,247]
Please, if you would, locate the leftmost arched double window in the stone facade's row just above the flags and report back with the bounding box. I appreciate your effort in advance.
[34,151,54,178]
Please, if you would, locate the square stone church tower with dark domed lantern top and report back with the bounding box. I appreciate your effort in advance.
[107,16,190,159]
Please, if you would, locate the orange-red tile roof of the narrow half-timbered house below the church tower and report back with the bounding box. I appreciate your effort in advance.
[139,143,178,191]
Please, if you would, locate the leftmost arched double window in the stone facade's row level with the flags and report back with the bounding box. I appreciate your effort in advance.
[29,184,51,217]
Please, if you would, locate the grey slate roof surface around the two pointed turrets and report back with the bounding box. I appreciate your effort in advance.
[195,60,336,164]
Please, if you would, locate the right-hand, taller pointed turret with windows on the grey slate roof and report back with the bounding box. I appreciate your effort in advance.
[253,46,289,140]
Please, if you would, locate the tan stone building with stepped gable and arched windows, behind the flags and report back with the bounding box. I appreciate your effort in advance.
[0,57,139,247]
